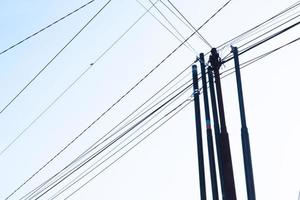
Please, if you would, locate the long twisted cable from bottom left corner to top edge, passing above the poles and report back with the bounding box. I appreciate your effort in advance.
[5,0,231,200]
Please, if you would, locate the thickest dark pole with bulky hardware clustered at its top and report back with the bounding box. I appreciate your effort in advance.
[209,48,236,200]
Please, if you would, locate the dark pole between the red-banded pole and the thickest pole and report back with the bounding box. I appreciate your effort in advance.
[207,68,225,200]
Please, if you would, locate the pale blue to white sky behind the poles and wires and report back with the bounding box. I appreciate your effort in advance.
[0,0,300,200]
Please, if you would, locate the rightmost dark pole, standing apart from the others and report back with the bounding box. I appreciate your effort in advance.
[232,47,256,200]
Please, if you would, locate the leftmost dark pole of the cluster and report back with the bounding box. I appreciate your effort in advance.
[192,65,206,200]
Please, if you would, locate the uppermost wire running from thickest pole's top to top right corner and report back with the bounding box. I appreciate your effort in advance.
[217,1,300,49]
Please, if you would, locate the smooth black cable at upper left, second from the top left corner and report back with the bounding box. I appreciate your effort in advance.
[0,0,112,114]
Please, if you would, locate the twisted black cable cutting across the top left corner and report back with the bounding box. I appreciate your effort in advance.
[0,0,95,55]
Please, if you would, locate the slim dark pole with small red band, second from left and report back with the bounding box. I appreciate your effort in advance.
[199,53,219,200]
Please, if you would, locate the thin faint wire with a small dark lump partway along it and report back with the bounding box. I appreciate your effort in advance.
[0,0,161,156]
